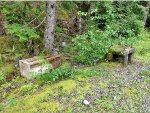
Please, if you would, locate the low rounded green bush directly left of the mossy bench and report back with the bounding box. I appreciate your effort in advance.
[72,29,110,65]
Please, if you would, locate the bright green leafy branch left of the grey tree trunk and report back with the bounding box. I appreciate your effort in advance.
[6,23,39,42]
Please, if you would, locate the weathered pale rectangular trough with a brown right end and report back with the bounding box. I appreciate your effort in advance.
[19,56,61,79]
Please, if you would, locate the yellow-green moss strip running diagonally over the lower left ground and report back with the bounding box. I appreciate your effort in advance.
[1,80,76,113]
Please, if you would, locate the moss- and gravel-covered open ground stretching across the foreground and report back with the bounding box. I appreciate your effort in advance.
[0,34,150,113]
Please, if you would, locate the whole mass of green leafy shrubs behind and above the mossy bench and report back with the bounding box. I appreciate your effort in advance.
[73,1,144,65]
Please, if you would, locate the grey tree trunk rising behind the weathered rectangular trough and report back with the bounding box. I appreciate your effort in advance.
[45,1,56,53]
